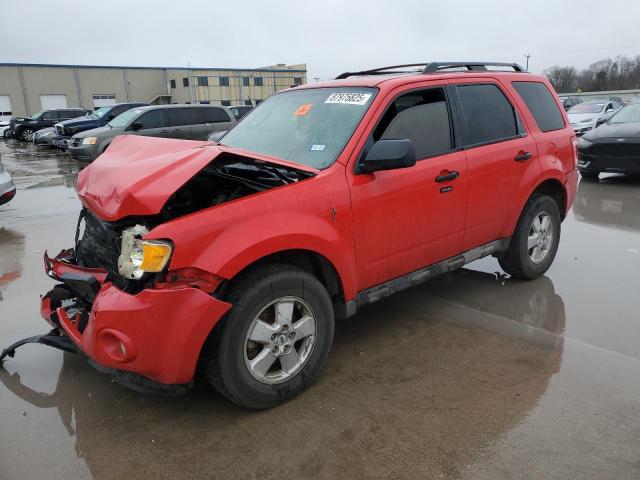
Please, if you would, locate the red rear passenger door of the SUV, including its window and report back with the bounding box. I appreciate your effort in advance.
[453,77,540,251]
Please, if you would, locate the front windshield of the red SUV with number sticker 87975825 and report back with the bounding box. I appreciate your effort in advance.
[220,87,377,169]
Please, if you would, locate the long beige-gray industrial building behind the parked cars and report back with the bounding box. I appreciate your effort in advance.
[0,63,307,120]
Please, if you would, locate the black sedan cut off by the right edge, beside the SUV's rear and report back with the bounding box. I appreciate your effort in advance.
[578,103,640,179]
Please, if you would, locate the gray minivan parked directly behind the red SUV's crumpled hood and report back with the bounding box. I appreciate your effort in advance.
[68,105,236,161]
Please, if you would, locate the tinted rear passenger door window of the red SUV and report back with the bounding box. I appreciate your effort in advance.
[458,85,518,145]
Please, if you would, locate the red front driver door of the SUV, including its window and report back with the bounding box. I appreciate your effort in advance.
[350,83,467,290]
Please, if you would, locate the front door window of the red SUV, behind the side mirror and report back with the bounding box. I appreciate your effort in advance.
[373,88,453,158]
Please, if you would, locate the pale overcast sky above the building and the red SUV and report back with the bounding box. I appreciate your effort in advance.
[0,0,640,80]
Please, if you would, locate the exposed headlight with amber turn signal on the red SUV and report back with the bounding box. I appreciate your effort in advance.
[118,225,172,280]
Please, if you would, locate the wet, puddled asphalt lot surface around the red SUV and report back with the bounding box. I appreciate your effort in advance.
[0,141,640,480]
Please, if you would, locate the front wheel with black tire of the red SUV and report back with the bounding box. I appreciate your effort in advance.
[200,264,334,410]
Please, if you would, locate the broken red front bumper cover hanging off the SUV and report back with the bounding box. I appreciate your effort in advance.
[1,249,231,385]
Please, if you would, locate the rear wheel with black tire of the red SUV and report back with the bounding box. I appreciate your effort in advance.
[498,194,561,280]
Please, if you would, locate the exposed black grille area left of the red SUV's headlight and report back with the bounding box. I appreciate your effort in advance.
[76,209,127,287]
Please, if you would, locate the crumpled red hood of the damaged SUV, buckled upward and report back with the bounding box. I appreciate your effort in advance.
[77,135,318,221]
